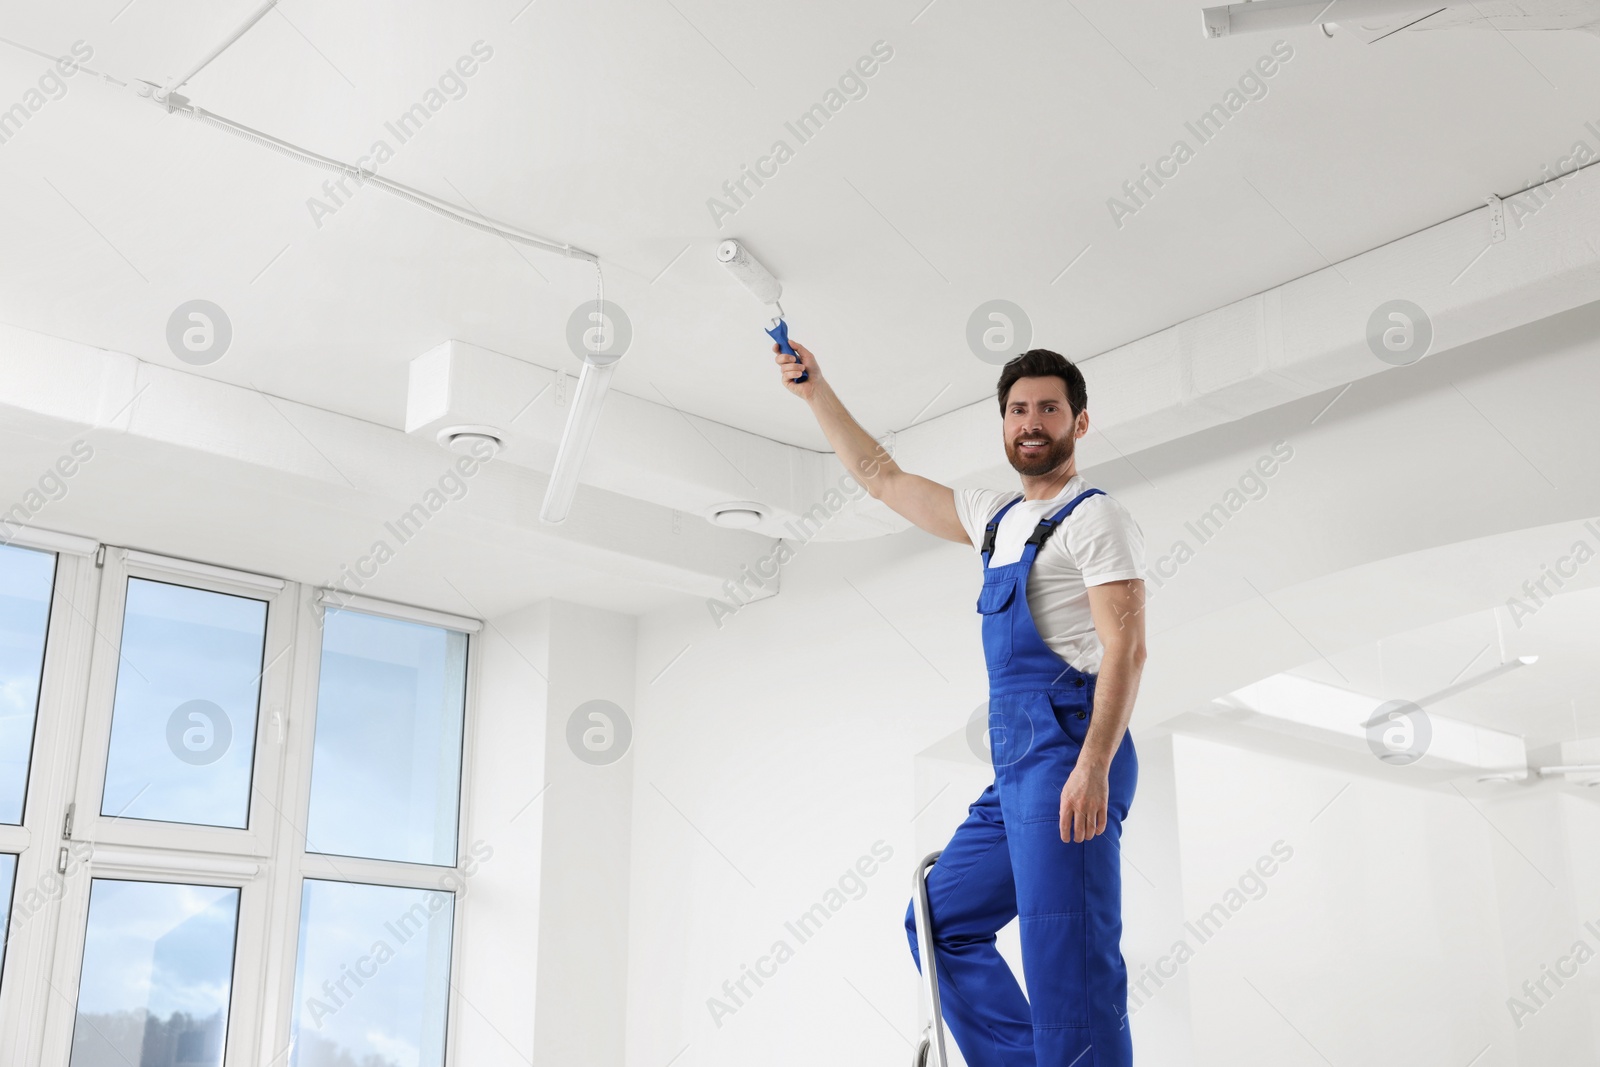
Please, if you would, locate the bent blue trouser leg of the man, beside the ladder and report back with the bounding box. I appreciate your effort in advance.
[906,785,1034,1067]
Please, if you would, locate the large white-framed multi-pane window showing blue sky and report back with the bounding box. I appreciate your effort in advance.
[0,539,477,1067]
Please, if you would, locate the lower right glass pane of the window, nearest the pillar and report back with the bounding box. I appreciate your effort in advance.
[288,878,456,1067]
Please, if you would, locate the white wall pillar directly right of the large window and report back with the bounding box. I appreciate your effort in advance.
[456,600,635,1067]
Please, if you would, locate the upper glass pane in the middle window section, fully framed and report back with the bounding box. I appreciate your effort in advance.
[101,577,267,829]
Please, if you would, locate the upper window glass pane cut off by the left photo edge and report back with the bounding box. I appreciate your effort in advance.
[0,545,56,824]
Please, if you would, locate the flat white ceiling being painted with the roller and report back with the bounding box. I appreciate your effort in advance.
[0,0,1600,446]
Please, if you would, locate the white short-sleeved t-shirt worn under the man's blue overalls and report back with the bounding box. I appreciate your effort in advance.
[955,475,1144,673]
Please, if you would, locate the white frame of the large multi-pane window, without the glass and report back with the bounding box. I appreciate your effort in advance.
[0,536,482,1067]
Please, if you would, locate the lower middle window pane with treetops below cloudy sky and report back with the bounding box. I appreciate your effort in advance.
[70,878,238,1067]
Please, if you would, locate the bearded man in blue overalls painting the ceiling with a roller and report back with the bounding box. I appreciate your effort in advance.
[773,341,1146,1067]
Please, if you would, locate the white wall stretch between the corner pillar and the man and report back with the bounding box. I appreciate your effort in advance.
[627,534,984,1065]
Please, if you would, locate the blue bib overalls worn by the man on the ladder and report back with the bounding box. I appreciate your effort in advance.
[906,490,1139,1067]
